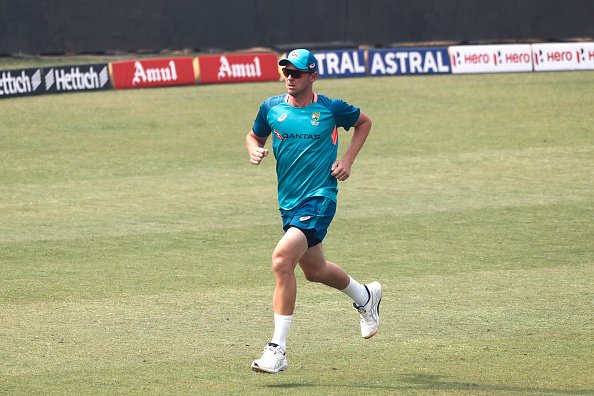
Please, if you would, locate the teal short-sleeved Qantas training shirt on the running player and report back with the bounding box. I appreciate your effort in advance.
[252,94,361,210]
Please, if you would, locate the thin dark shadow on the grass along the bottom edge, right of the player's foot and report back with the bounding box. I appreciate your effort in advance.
[266,374,594,395]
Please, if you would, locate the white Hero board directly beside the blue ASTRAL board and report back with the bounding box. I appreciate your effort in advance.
[449,44,532,74]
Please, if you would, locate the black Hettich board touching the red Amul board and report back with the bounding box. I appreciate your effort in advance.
[43,63,111,93]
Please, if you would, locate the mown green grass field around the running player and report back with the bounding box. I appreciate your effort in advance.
[0,64,594,395]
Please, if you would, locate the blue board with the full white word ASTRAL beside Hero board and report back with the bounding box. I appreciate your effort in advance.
[368,48,450,76]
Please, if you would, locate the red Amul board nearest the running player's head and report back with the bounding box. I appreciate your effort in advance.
[195,53,280,84]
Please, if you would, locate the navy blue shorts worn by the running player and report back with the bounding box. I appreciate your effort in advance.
[280,197,336,247]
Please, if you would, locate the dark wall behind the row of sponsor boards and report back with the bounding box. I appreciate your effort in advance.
[0,0,594,55]
